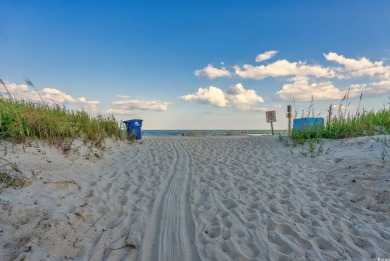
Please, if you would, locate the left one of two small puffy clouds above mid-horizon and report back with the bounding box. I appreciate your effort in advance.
[181,86,229,108]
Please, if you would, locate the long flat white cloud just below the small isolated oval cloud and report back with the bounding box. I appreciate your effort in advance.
[234,60,336,80]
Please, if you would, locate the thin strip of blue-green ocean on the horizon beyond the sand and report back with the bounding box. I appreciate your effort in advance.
[142,130,287,137]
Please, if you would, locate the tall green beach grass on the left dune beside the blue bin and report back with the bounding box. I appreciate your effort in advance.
[0,97,132,150]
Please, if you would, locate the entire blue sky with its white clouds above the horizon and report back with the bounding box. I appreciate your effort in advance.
[0,0,390,129]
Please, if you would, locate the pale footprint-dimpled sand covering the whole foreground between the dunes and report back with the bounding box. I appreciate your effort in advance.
[0,136,390,260]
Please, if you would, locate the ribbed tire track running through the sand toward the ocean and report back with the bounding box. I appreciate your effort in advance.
[142,139,200,261]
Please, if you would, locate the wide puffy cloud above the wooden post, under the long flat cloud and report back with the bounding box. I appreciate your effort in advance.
[277,76,345,101]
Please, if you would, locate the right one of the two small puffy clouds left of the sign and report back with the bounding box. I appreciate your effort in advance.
[226,83,264,110]
